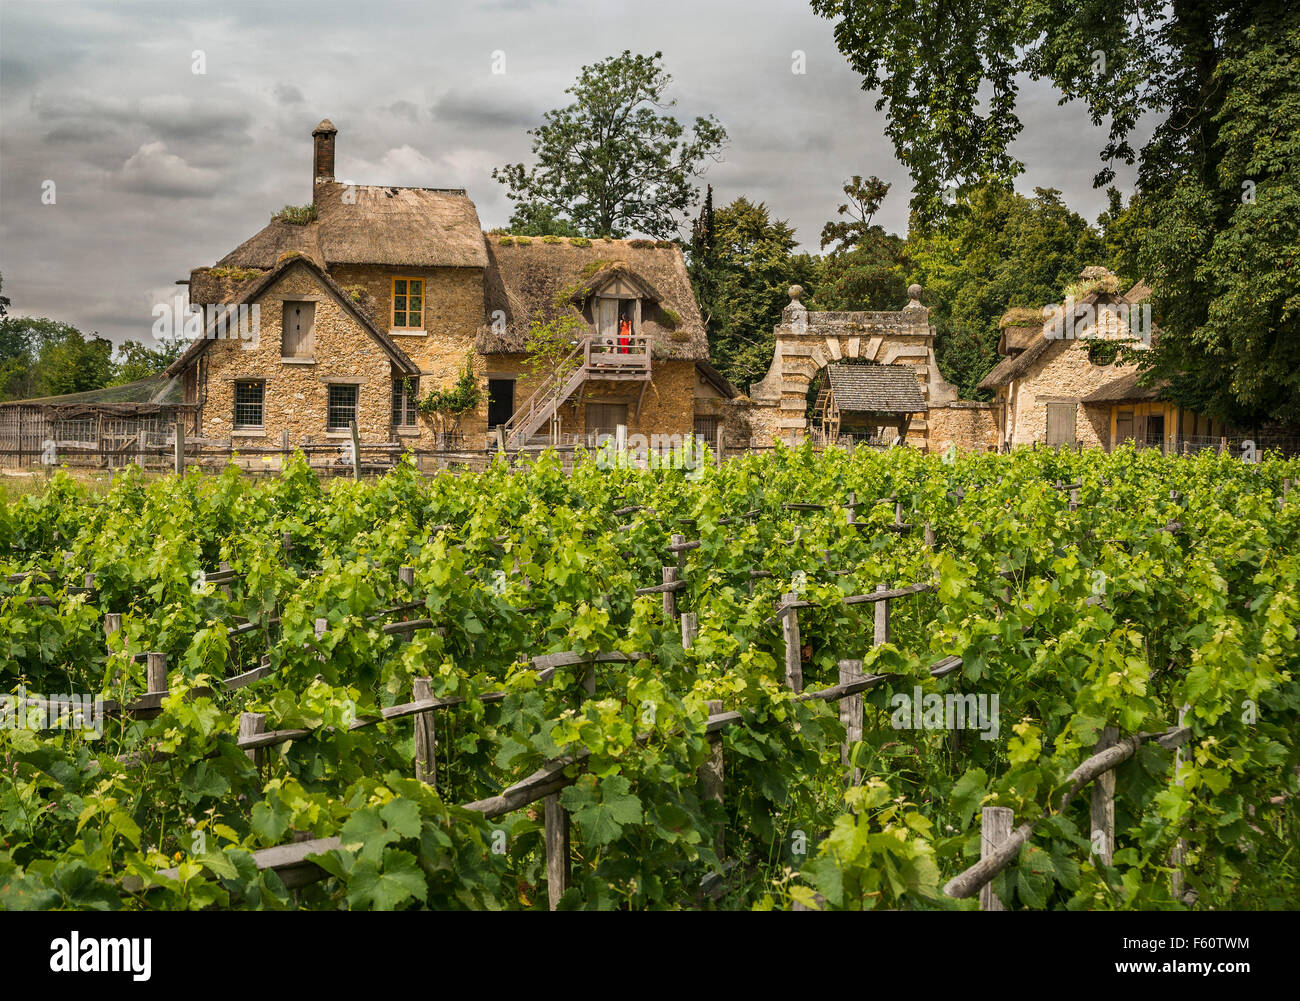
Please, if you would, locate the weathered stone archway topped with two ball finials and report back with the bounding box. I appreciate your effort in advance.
[749,285,957,447]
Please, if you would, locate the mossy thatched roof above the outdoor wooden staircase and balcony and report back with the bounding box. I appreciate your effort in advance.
[475,234,709,361]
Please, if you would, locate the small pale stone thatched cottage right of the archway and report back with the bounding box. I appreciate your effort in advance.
[979,268,1226,451]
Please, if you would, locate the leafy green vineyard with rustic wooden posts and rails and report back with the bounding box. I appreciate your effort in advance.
[0,446,1300,910]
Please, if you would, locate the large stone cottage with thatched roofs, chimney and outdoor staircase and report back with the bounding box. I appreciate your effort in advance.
[168,120,736,447]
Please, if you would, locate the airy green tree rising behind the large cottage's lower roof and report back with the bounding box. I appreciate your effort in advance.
[493,49,727,239]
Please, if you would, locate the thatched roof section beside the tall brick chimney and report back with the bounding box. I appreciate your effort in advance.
[217,181,488,268]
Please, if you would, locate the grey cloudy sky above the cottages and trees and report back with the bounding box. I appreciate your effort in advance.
[0,0,1131,341]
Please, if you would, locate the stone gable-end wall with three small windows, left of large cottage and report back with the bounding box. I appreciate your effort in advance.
[199,268,393,447]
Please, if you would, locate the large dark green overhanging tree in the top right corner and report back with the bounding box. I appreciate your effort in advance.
[811,0,1300,420]
